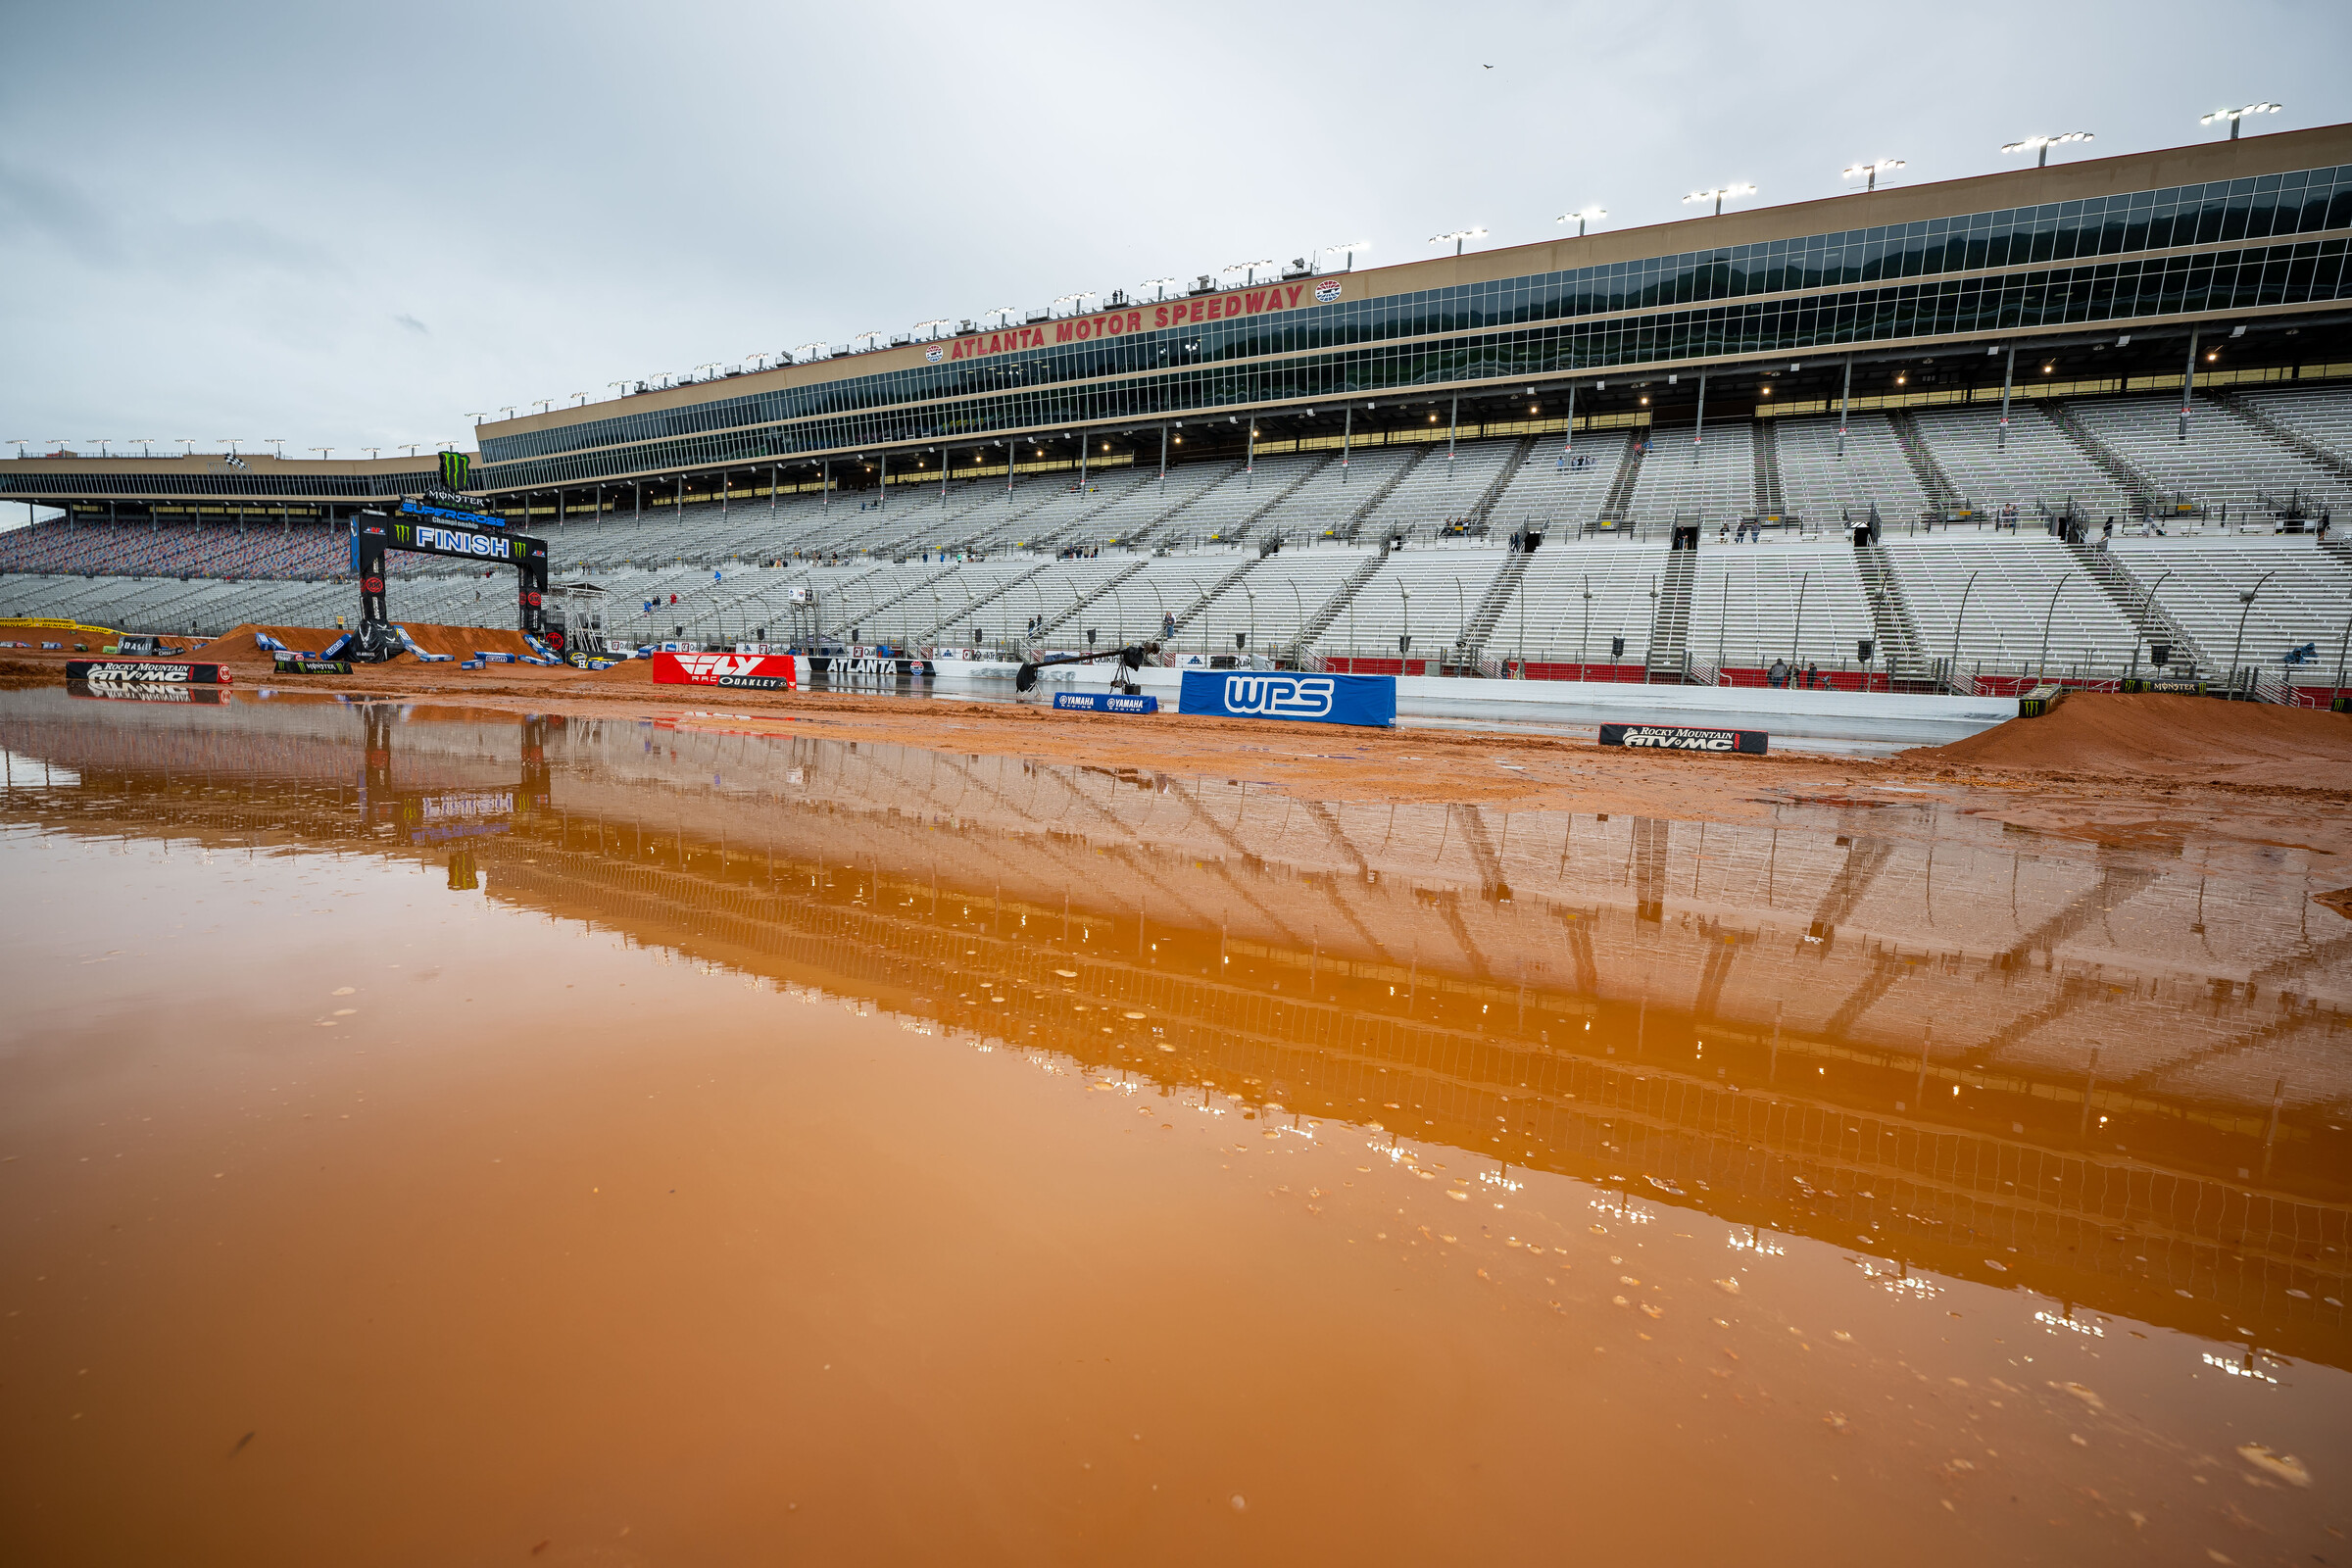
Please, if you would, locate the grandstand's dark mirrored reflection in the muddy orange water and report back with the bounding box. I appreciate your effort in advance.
[0,703,2352,1363]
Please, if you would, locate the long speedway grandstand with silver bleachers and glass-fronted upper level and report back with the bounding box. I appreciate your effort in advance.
[14,127,2352,701]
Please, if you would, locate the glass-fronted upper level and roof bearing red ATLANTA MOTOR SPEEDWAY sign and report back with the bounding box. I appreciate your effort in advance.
[14,124,2352,526]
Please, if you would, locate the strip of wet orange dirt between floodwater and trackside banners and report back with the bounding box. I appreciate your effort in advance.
[33,627,2352,858]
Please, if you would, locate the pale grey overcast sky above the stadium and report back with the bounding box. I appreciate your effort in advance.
[0,0,2352,456]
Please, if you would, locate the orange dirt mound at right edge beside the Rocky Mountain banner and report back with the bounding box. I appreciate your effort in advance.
[1903,694,2352,790]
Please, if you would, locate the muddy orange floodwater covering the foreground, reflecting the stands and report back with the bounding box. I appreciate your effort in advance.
[0,691,2352,1563]
